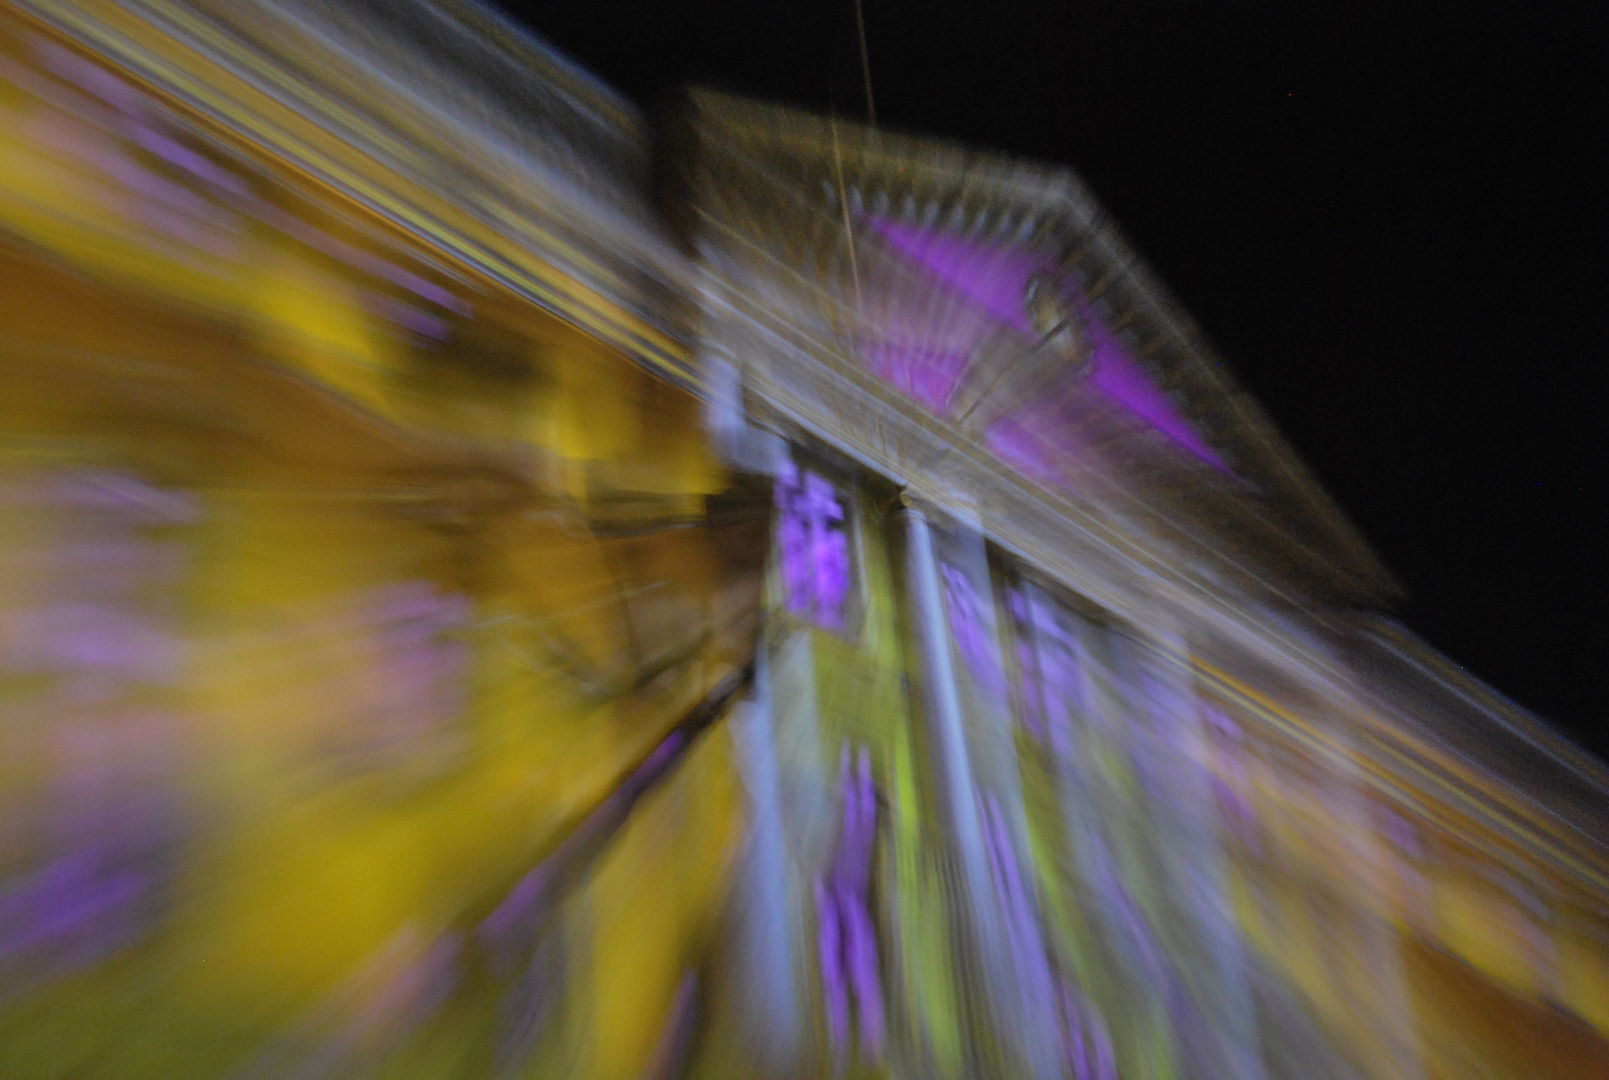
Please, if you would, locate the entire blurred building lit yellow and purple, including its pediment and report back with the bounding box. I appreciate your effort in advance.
[0,0,1609,1080]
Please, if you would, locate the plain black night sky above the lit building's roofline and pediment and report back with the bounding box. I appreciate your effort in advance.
[502,0,1609,758]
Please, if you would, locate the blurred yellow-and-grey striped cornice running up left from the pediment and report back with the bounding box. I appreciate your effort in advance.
[14,0,697,385]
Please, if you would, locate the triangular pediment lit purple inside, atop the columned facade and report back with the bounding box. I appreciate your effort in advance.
[689,92,1395,600]
